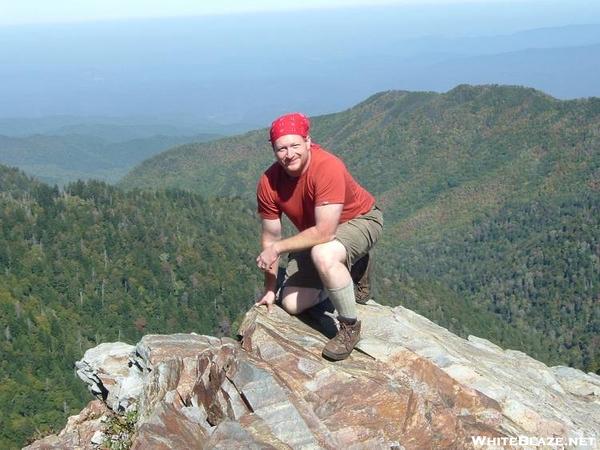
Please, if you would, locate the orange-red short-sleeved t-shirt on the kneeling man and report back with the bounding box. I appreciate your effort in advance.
[256,144,375,231]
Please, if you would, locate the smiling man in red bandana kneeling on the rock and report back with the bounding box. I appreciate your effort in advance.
[256,113,383,360]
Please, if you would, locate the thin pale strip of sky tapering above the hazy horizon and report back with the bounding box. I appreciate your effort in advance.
[0,0,544,25]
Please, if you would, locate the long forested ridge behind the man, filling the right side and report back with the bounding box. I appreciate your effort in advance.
[122,85,600,371]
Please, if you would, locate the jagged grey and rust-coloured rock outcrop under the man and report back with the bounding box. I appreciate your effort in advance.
[24,302,600,449]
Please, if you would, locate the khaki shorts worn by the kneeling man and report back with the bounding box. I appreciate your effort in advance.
[284,206,383,289]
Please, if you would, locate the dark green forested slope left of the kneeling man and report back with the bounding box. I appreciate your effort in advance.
[0,166,261,449]
